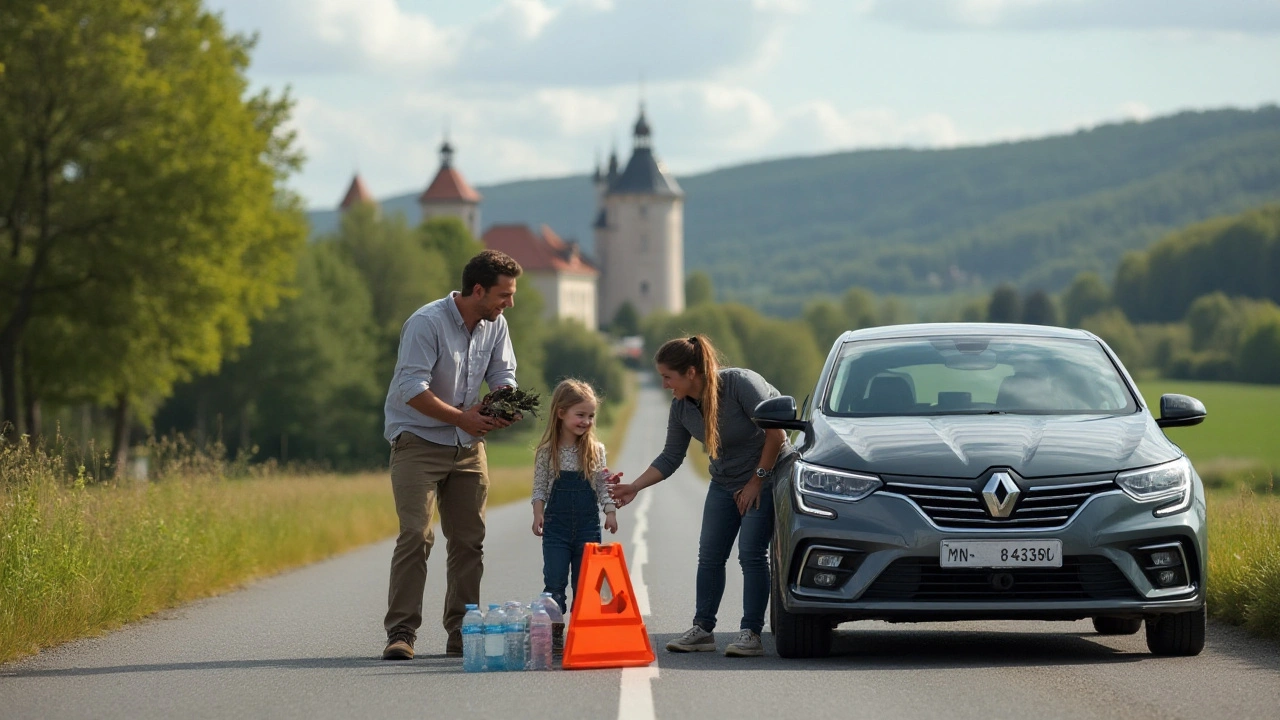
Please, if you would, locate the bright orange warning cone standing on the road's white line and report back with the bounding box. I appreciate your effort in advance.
[562,542,653,670]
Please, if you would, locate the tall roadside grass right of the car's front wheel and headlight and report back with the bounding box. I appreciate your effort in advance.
[1208,491,1280,639]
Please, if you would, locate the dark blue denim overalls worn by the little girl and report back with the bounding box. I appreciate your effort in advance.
[543,470,600,612]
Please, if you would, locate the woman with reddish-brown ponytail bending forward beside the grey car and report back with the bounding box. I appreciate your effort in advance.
[613,336,791,657]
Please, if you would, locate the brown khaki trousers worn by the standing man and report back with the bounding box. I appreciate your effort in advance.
[383,433,489,652]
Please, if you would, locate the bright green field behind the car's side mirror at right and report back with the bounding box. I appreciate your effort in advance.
[1139,380,1280,475]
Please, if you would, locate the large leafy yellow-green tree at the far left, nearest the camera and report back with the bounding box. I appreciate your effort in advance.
[0,0,305,464]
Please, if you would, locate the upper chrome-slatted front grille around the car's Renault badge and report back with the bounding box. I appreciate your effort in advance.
[883,478,1119,530]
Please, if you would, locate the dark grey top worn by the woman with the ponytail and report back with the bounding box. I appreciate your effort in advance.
[652,368,791,491]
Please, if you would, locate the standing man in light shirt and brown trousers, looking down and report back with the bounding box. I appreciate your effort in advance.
[383,250,521,660]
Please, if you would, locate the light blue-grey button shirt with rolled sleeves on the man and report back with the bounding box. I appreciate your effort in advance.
[383,292,516,447]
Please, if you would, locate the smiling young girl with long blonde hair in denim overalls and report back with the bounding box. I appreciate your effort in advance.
[532,379,622,648]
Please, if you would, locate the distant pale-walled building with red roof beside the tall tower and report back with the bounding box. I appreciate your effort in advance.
[484,224,600,331]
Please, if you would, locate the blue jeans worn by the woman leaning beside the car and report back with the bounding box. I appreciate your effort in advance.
[694,482,773,634]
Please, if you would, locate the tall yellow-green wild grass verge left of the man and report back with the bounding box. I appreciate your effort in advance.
[0,430,396,662]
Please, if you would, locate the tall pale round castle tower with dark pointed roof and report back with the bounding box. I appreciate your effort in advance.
[595,105,685,324]
